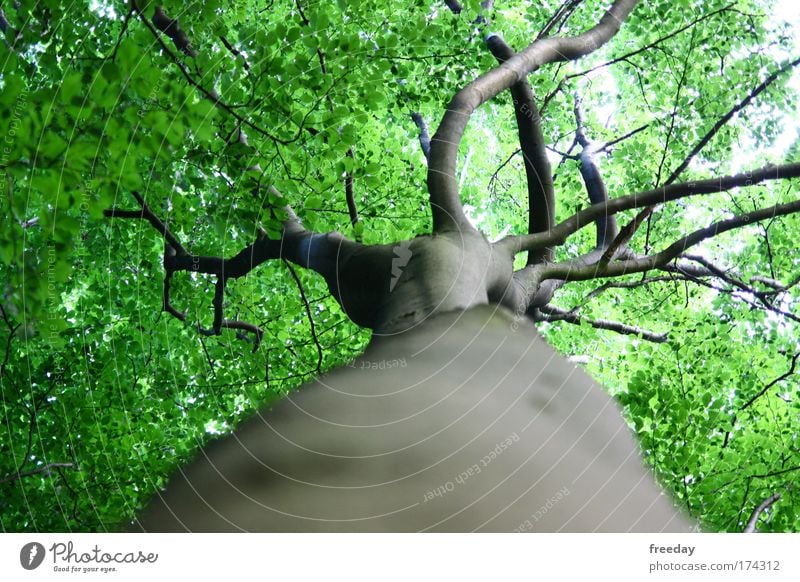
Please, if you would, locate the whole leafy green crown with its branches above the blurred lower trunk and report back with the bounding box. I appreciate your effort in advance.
[0,0,800,530]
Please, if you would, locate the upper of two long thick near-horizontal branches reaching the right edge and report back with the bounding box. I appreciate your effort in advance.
[496,163,800,254]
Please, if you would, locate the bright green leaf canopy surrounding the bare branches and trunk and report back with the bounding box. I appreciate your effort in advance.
[0,0,800,531]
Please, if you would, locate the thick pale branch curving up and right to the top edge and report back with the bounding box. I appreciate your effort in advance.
[428,0,636,232]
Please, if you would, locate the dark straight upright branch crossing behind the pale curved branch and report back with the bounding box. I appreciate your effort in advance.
[486,35,555,265]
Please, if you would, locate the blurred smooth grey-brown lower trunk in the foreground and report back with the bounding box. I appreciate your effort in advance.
[140,305,691,532]
